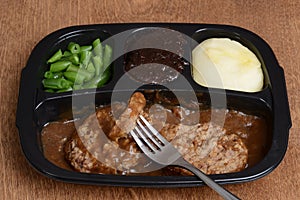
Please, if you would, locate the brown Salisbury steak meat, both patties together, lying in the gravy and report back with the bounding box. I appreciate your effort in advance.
[65,92,248,174]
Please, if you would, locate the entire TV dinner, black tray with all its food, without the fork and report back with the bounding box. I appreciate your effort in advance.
[16,23,291,187]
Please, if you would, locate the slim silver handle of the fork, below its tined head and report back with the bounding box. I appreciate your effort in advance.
[173,157,239,200]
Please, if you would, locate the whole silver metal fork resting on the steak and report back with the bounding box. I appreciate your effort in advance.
[130,115,239,200]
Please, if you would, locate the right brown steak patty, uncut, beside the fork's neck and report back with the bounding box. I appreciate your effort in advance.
[163,123,248,174]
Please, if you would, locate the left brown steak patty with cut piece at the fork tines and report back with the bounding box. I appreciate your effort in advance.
[65,92,146,174]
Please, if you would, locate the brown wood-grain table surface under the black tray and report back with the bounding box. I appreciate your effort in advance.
[0,0,300,199]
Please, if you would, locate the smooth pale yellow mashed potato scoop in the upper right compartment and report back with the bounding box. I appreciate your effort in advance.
[192,38,264,92]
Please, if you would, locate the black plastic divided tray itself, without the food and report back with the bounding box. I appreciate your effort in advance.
[16,23,291,187]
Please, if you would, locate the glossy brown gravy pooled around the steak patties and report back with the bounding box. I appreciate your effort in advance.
[41,106,270,175]
